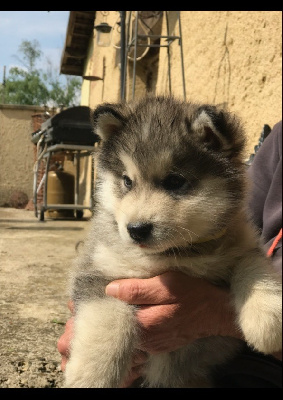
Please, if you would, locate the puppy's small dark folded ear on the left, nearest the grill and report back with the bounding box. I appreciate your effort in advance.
[92,103,125,141]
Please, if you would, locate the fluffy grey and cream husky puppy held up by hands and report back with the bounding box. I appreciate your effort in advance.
[65,96,282,388]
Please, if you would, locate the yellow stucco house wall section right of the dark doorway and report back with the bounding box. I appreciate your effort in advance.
[157,11,282,157]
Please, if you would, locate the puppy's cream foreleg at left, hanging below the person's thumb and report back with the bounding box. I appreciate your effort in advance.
[65,298,138,388]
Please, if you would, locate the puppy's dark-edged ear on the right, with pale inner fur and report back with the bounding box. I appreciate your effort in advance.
[191,105,245,157]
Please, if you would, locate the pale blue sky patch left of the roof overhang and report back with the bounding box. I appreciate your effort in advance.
[0,10,70,83]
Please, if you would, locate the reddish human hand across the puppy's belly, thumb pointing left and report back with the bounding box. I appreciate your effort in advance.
[106,272,242,354]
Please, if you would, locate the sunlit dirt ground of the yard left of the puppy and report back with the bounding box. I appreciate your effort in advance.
[0,208,89,388]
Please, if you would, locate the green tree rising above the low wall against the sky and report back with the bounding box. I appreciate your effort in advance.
[0,40,81,107]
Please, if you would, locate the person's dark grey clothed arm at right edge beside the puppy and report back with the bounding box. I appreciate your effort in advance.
[248,121,282,276]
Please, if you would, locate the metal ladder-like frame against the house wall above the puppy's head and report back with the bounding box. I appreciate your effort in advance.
[121,11,186,100]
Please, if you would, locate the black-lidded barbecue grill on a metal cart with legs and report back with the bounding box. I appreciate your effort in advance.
[32,106,99,221]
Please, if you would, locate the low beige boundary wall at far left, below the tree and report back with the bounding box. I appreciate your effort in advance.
[0,104,52,206]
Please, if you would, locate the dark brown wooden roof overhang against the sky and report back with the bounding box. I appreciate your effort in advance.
[60,11,96,76]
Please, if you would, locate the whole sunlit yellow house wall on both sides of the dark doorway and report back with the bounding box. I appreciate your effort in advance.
[82,11,282,156]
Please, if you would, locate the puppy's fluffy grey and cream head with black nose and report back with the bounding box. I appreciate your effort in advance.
[93,96,244,252]
